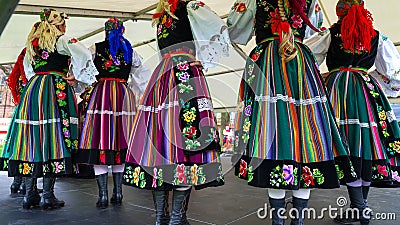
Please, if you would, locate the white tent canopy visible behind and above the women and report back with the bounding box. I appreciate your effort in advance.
[0,0,400,111]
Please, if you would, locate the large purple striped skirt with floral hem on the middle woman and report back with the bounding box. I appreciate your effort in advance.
[124,49,223,190]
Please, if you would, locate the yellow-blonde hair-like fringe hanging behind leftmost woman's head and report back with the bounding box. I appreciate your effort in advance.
[26,20,64,63]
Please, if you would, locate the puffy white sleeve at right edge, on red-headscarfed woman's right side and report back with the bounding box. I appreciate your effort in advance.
[370,33,400,97]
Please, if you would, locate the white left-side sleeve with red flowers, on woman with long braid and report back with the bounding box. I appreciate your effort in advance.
[227,0,257,45]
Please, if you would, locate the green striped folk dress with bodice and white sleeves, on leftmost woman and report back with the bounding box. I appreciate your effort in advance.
[0,35,97,178]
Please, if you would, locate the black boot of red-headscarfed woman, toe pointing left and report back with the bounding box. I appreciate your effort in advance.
[334,186,370,225]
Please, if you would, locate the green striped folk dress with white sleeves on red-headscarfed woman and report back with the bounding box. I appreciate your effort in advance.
[307,24,400,188]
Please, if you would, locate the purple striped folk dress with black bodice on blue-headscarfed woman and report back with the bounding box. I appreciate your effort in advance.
[76,40,150,165]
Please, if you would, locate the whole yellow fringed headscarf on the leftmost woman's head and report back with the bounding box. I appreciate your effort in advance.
[26,8,68,62]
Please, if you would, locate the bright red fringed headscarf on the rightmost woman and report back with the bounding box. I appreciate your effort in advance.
[336,0,376,53]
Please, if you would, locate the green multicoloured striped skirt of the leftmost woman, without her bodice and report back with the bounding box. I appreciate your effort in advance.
[2,72,78,177]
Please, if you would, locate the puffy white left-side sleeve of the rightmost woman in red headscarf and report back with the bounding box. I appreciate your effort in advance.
[304,29,331,65]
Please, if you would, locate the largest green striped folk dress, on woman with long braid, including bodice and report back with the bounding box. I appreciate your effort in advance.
[228,0,355,190]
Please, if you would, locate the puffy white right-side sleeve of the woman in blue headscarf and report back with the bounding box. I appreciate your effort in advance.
[128,50,151,98]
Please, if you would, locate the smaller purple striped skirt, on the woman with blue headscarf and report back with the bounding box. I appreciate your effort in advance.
[75,78,136,165]
